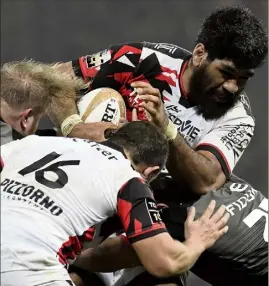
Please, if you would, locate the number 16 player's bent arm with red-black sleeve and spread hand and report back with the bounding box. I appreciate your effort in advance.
[113,178,228,277]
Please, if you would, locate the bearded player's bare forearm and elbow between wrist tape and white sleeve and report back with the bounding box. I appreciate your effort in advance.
[167,134,222,194]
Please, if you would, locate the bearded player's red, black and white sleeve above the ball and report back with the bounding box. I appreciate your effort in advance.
[72,42,152,121]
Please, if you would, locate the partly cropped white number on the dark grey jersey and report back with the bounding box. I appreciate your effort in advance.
[243,199,268,242]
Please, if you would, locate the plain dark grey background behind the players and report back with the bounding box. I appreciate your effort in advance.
[1,0,268,286]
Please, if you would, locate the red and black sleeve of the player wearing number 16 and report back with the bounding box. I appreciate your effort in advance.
[117,178,166,243]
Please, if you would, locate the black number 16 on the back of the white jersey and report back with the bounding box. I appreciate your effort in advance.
[19,152,80,189]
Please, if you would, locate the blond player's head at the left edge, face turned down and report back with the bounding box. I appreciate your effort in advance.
[0,60,97,145]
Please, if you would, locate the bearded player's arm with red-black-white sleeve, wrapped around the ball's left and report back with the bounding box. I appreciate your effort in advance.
[48,43,143,141]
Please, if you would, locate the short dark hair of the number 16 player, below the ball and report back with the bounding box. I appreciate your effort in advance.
[109,121,169,168]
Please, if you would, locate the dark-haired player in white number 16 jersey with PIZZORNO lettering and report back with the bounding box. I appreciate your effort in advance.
[1,122,229,286]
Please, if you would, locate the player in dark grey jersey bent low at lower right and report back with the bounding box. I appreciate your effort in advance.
[73,175,268,286]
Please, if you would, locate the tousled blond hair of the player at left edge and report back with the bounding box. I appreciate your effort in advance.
[1,60,88,113]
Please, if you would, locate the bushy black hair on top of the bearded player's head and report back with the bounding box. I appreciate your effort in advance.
[196,6,268,69]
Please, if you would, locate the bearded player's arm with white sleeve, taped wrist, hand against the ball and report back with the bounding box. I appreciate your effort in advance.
[132,82,255,194]
